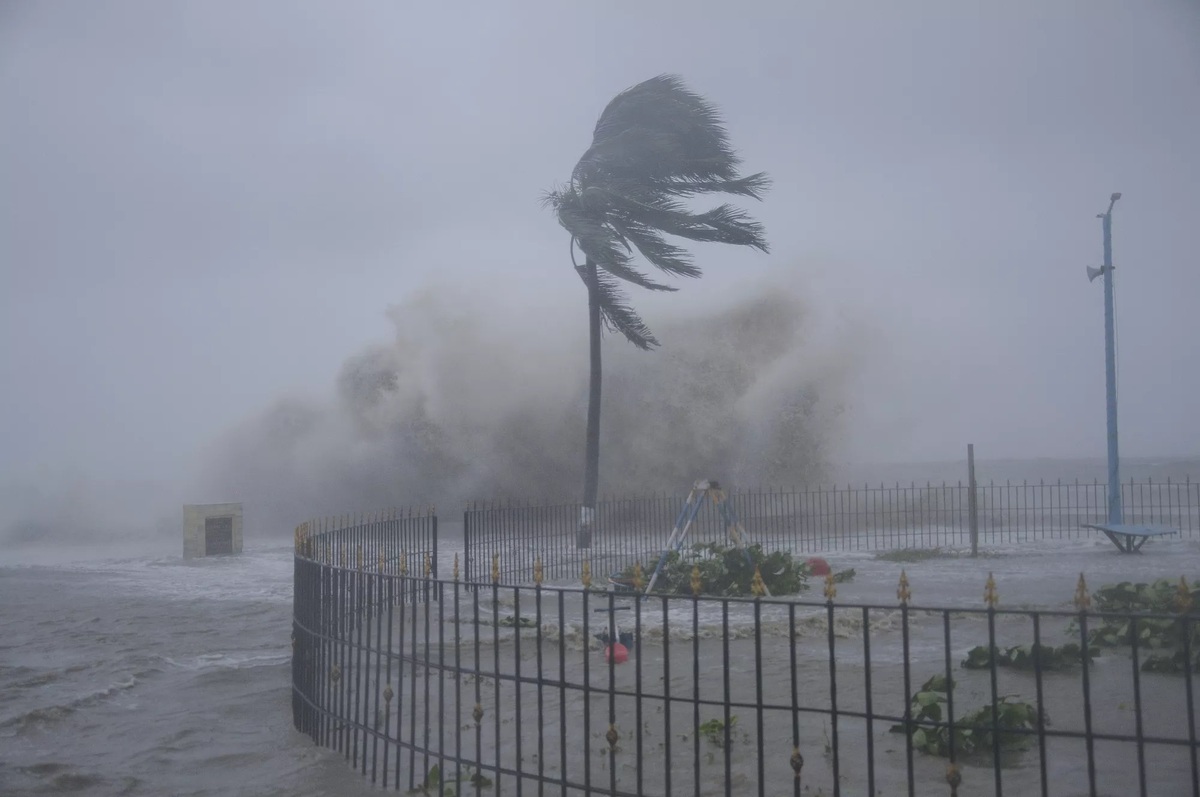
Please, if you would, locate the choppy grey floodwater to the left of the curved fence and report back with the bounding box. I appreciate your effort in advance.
[0,546,384,797]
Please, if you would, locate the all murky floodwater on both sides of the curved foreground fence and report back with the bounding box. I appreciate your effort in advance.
[0,523,1200,797]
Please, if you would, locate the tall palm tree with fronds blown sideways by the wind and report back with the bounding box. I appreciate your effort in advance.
[546,74,768,547]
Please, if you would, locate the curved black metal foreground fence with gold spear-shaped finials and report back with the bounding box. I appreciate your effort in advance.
[293,513,1200,797]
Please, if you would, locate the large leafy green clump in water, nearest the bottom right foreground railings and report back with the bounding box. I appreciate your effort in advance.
[889,676,1049,756]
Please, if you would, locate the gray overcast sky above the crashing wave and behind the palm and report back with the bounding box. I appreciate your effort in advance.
[0,0,1200,492]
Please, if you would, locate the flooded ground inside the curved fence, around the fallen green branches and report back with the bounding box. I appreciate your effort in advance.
[316,528,1200,796]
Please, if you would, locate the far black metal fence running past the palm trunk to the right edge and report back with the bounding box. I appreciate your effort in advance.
[463,479,1200,583]
